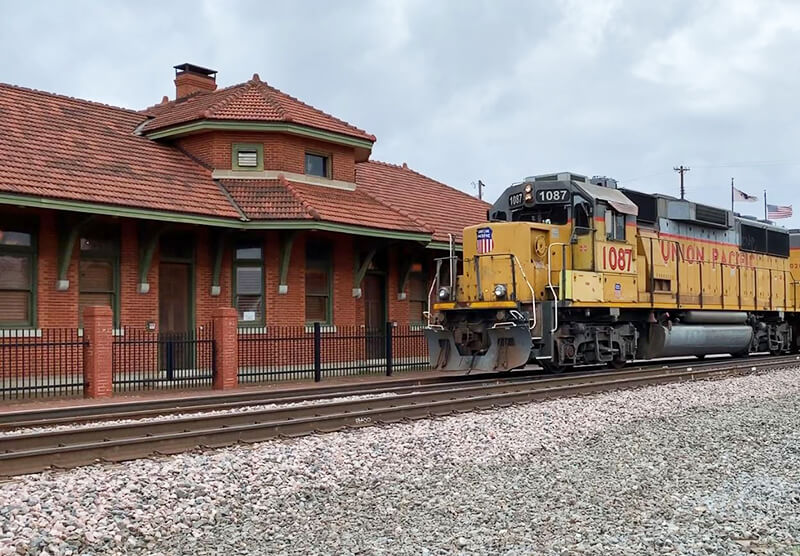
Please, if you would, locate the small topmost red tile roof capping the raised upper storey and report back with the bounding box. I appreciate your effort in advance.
[143,75,375,142]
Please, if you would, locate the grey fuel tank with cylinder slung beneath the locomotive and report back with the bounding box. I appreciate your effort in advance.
[637,324,753,359]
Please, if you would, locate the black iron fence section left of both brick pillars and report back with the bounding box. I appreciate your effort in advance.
[0,328,86,400]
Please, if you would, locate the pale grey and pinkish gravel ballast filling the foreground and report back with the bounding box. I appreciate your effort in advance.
[0,369,800,554]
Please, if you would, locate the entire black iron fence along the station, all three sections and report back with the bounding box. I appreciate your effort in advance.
[0,324,429,400]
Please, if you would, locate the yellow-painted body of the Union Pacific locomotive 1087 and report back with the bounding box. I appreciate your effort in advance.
[444,212,800,311]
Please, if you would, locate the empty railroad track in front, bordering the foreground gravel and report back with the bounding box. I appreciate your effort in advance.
[0,356,798,476]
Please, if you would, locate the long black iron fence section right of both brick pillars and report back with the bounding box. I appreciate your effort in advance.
[238,323,429,383]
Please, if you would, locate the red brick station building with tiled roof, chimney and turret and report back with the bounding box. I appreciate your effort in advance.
[0,64,487,332]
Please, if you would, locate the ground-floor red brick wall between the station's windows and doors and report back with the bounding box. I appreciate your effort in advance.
[0,210,428,329]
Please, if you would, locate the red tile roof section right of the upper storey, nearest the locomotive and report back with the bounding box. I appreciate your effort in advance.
[356,161,490,242]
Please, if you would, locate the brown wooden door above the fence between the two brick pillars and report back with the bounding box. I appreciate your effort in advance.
[158,263,192,332]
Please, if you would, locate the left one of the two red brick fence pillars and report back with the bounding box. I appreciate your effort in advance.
[83,307,114,398]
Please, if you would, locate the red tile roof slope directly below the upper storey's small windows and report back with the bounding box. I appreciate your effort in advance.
[221,179,431,234]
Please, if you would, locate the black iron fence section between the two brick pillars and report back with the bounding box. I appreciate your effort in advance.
[111,324,216,391]
